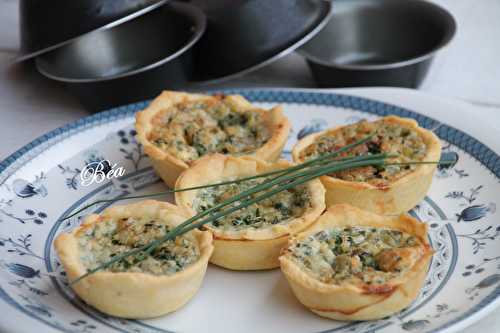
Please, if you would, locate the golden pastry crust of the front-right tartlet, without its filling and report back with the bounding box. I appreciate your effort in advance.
[280,204,433,320]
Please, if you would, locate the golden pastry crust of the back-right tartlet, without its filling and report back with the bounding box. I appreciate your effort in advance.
[292,116,441,215]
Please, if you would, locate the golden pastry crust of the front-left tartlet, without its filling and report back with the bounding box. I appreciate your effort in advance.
[55,200,213,319]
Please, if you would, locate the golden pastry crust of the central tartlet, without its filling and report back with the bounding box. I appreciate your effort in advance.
[175,154,325,270]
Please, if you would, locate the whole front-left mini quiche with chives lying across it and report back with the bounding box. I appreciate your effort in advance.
[55,200,213,319]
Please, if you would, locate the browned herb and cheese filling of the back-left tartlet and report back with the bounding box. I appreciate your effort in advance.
[150,99,271,162]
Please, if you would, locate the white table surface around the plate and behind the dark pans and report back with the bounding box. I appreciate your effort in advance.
[0,0,500,333]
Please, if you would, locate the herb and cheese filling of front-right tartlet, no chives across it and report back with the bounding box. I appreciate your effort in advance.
[286,227,421,285]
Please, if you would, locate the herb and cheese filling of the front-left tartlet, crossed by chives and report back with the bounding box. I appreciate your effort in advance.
[78,217,200,275]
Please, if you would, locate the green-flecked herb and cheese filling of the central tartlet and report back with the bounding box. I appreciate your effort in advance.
[193,178,311,230]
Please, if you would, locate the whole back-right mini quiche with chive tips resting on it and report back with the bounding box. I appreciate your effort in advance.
[292,116,441,214]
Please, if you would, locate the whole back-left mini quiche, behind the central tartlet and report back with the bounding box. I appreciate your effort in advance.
[135,91,290,187]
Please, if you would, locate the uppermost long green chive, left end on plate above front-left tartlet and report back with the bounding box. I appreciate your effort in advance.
[61,134,374,221]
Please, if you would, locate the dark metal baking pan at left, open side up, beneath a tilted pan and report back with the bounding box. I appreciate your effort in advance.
[36,1,206,111]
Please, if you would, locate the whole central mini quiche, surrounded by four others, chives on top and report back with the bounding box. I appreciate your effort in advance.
[175,154,325,270]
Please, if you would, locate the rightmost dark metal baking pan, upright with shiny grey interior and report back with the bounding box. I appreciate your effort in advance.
[298,0,456,88]
